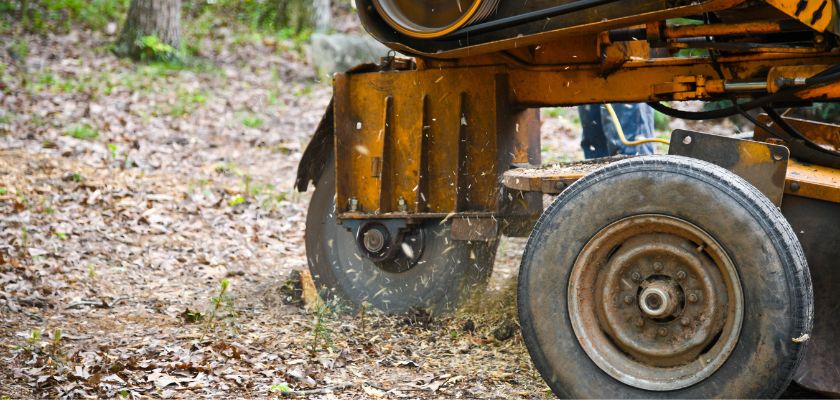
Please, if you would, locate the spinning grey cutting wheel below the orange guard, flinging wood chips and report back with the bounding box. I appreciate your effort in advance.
[305,157,498,313]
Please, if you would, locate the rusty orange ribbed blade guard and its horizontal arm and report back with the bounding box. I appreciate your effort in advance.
[334,48,840,219]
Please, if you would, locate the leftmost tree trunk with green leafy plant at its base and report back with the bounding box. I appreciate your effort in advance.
[115,0,181,59]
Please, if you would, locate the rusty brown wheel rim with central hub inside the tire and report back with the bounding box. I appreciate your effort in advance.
[568,215,744,391]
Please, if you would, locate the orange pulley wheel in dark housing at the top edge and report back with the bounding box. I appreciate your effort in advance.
[373,0,499,39]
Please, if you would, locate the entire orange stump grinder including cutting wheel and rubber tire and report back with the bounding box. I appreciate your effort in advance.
[297,0,840,398]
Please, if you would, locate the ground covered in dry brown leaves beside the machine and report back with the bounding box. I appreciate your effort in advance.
[0,27,592,399]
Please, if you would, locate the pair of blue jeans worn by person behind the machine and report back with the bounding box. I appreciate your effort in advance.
[578,103,654,159]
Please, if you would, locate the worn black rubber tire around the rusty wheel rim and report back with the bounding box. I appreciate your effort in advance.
[518,156,813,398]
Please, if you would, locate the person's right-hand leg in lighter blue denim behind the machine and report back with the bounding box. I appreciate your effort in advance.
[601,103,654,155]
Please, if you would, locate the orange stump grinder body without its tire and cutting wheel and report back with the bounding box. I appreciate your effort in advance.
[298,0,840,394]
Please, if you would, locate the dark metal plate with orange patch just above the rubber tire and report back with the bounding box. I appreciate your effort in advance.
[668,129,790,206]
